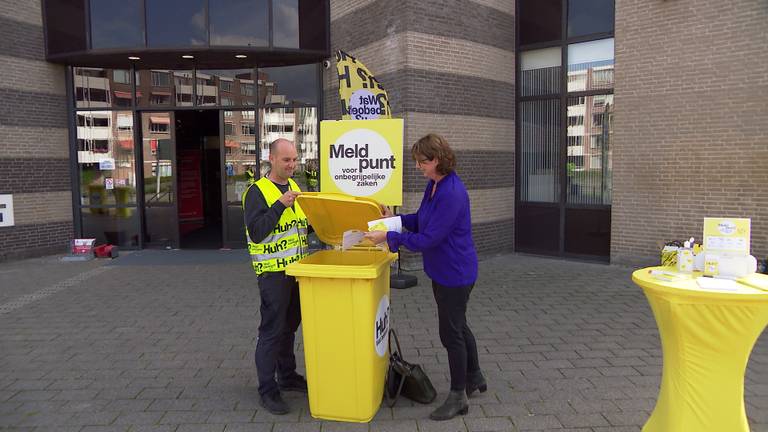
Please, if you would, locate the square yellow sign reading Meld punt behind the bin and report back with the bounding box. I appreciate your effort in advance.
[320,119,403,206]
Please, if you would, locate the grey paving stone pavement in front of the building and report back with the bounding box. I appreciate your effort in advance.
[0,251,768,432]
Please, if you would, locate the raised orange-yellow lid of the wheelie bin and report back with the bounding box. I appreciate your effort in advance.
[296,192,383,245]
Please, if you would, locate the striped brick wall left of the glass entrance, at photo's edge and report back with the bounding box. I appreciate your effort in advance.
[0,0,72,261]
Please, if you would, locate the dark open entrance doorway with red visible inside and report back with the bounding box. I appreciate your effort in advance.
[176,110,222,249]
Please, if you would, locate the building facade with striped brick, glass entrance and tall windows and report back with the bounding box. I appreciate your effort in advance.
[0,0,768,264]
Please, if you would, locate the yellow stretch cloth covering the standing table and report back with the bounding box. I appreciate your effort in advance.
[632,267,768,432]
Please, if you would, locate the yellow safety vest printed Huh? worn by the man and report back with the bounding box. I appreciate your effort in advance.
[243,177,309,275]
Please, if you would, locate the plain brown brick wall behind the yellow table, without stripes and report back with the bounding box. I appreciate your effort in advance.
[611,0,768,264]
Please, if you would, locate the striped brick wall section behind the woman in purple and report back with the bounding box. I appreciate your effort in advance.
[324,0,515,267]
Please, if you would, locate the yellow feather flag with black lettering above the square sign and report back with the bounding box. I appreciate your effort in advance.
[336,50,392,120]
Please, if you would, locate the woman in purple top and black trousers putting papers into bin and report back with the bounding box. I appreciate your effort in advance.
[366,134,488,420]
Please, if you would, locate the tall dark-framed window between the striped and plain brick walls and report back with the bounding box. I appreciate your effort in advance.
[520,0,615,258]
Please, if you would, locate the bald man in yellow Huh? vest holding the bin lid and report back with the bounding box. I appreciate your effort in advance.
[243,138,309,414]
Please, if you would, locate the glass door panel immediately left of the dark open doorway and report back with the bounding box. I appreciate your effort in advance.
[141,111,179,249]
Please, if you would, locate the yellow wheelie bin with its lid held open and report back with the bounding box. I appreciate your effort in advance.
[285,193,397,422]
